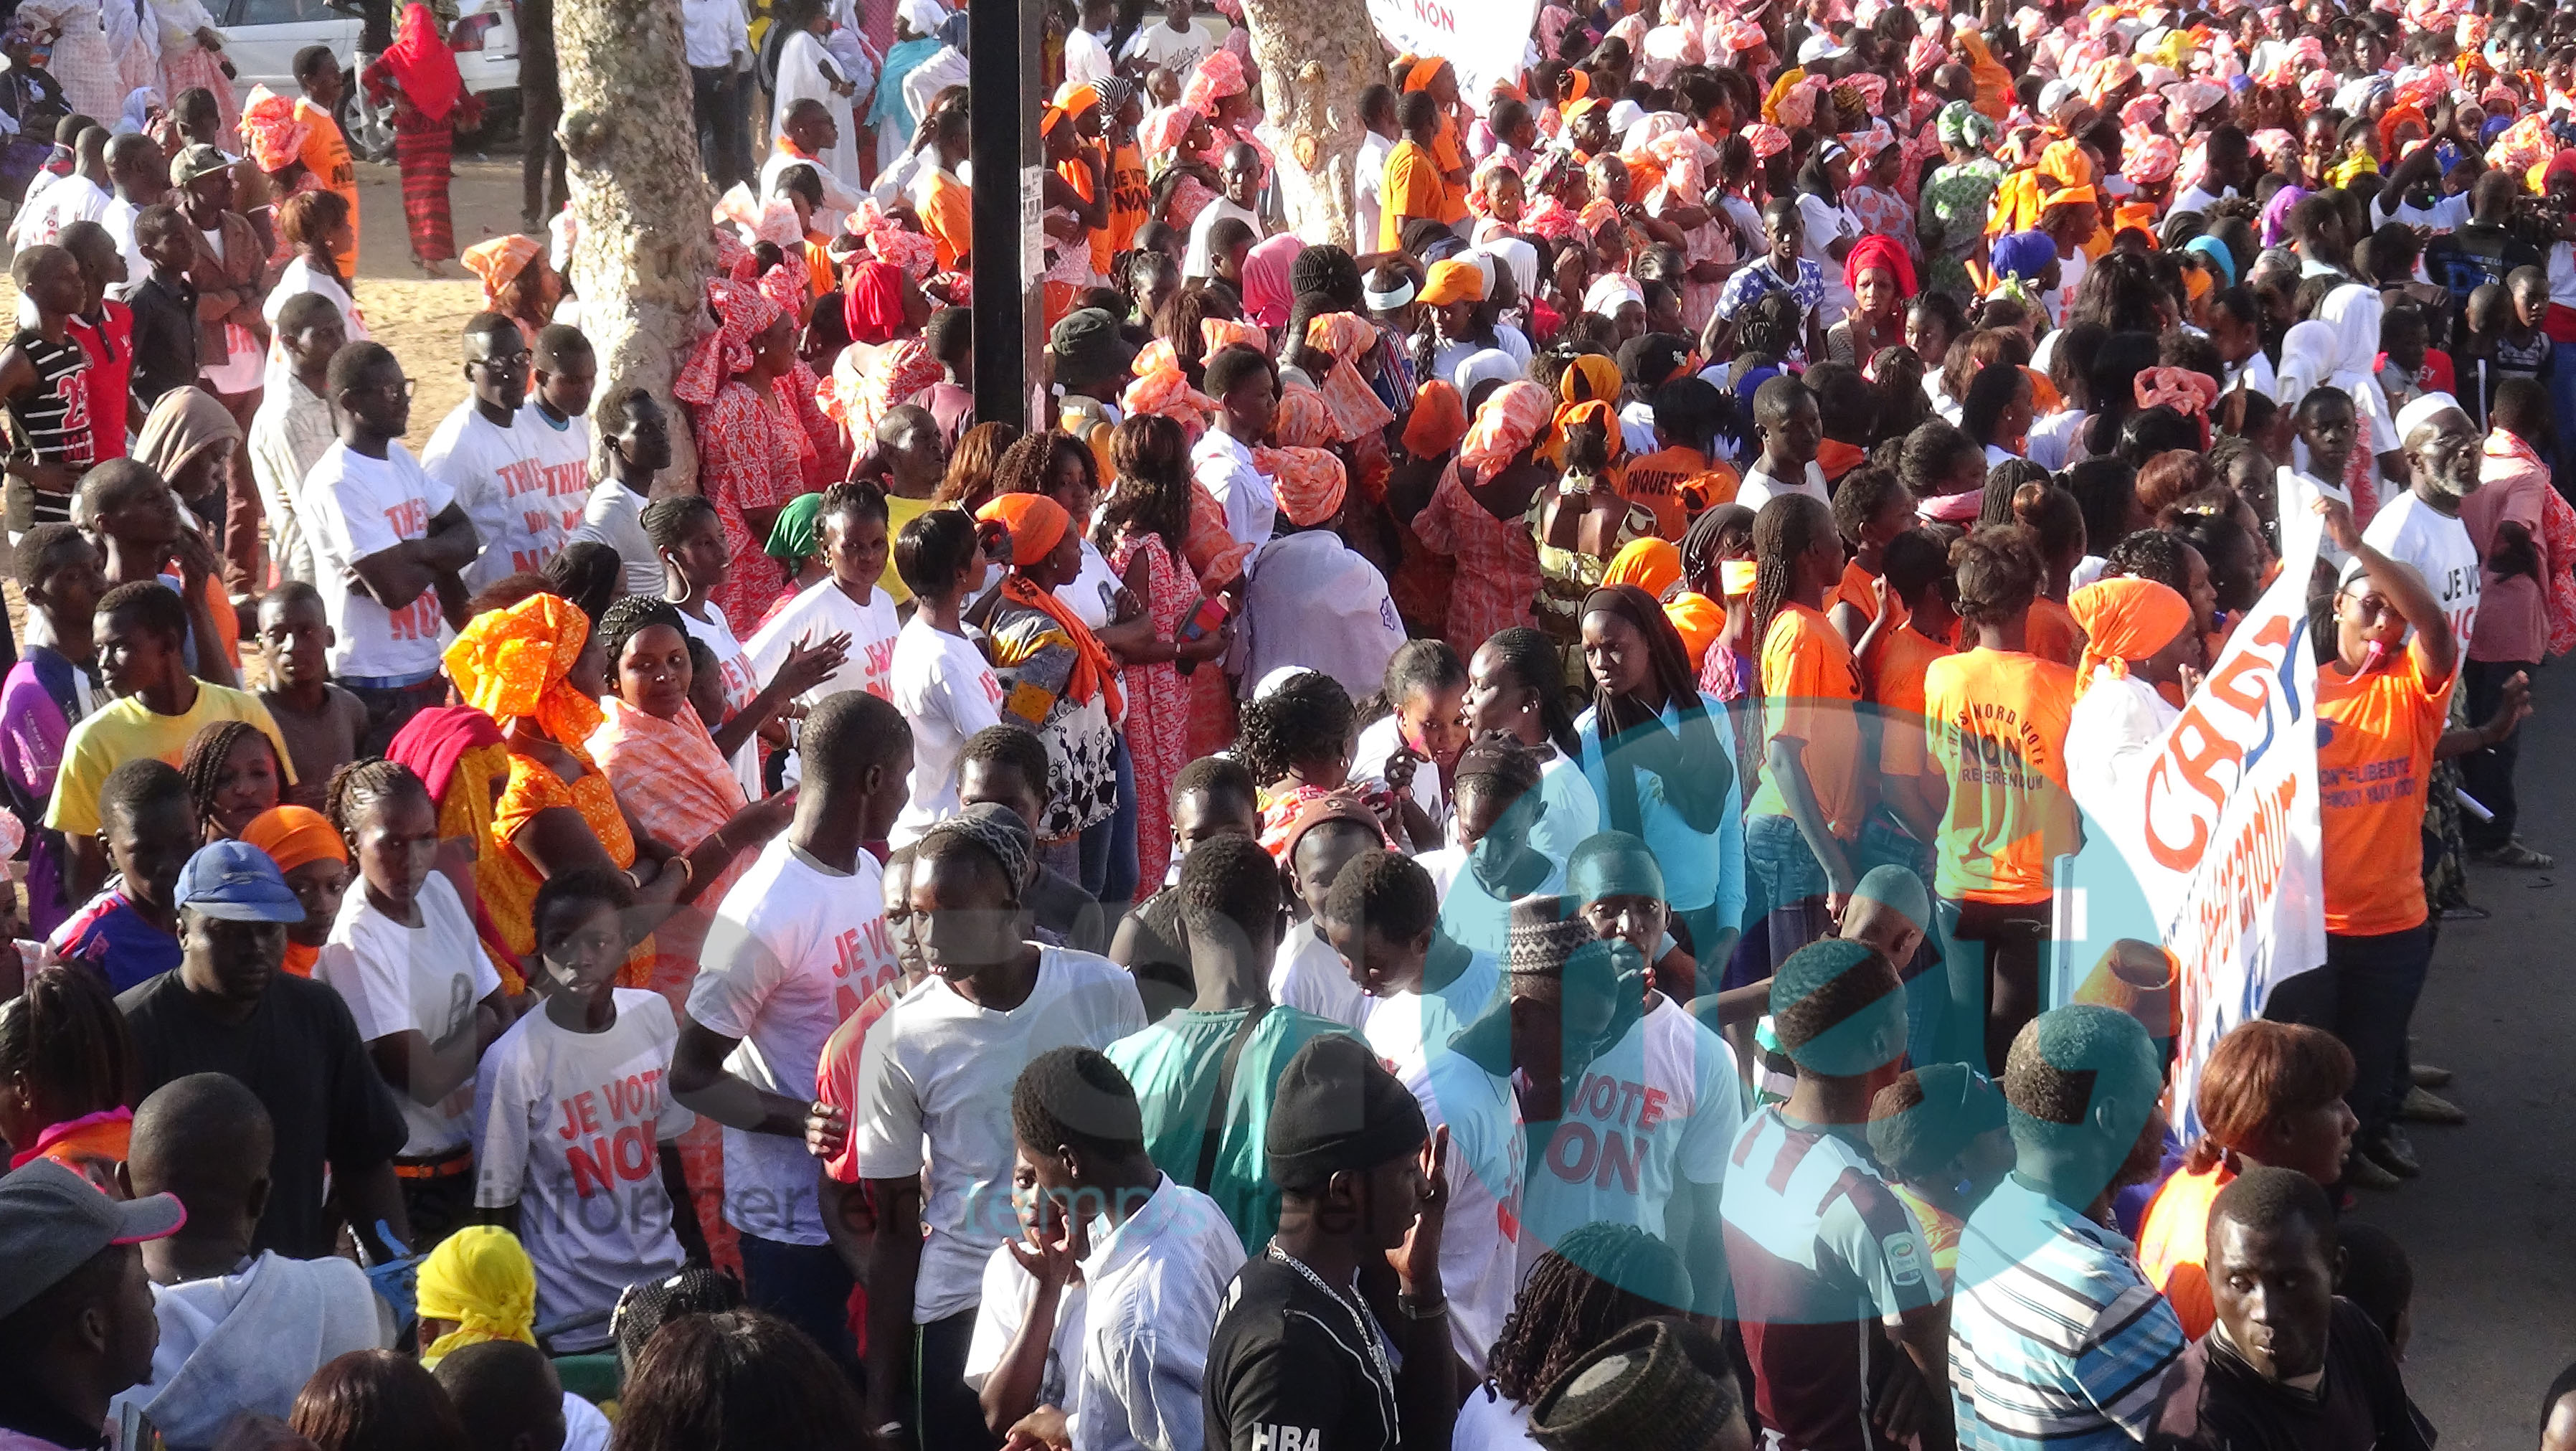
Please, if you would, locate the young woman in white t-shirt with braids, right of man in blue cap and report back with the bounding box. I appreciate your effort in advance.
[314,760,510,1245]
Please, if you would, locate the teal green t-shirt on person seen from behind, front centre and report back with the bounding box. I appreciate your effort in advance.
[1102,1008,1350,1245]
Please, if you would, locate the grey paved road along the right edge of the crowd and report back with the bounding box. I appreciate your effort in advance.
[2357,652,2576,1451]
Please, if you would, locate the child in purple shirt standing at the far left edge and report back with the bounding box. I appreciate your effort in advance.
[0,523,108,941]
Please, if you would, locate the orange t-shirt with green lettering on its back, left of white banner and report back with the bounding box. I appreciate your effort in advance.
[1924,647,2079,904]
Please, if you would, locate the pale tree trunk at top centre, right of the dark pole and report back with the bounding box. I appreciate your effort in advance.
[1244,0,1386,252]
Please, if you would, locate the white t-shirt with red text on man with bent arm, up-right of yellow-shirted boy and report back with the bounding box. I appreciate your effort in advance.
[299,443,456,681]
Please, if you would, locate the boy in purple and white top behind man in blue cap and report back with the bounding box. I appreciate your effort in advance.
[44,760,201,992]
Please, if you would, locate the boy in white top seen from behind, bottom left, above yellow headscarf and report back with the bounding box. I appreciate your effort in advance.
[118,1072,394,1446]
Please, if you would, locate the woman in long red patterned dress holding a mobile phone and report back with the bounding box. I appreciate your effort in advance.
[1095,415,1228,882]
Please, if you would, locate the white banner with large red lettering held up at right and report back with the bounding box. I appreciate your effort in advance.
[2087,510,2326,1142]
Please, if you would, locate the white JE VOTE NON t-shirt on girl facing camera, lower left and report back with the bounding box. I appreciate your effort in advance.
[474,987,696,1351]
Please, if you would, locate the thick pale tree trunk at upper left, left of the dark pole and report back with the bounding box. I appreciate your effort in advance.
[554,0,716,495]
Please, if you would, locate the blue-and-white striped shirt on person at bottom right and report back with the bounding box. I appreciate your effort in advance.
[1950,1178,2182,1451]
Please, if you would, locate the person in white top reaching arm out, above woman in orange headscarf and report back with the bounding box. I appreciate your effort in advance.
[641,495,850,799]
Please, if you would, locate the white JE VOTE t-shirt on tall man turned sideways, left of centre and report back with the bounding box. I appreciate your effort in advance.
[688,835,906,1245]
